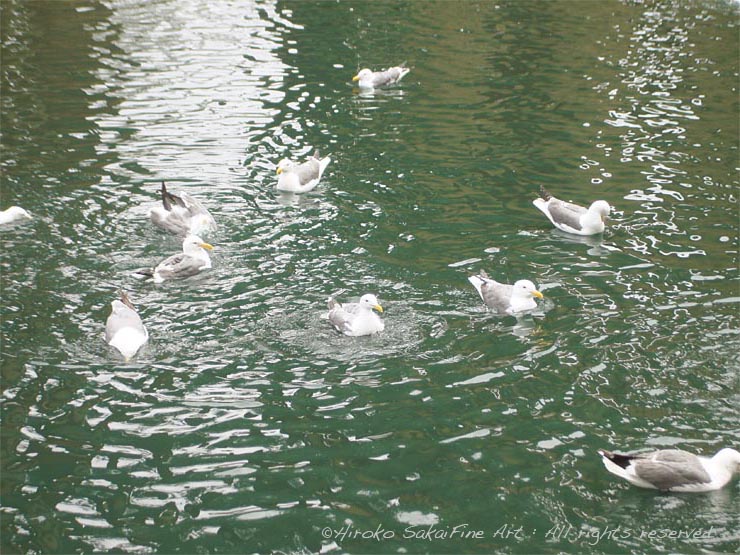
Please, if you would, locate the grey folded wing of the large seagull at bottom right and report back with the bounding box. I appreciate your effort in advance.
[633,449,712,490]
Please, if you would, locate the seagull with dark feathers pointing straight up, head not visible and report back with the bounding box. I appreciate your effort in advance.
[149,181,216,237]
